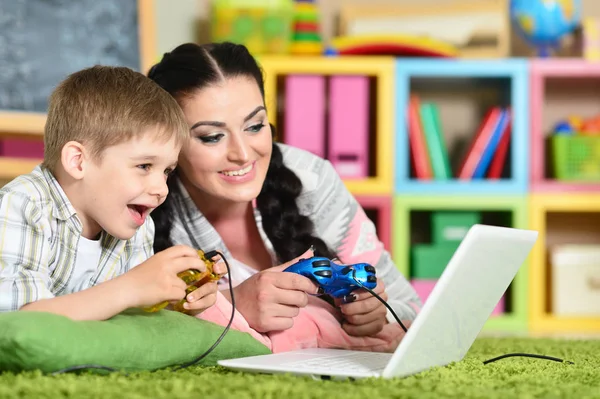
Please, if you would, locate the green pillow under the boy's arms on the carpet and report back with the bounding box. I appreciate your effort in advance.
[0,309,271,372]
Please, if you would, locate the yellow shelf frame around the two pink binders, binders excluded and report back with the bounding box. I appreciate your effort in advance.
[257,55,395,195]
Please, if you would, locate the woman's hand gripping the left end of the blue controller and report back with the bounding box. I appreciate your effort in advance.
[221,250,319,333]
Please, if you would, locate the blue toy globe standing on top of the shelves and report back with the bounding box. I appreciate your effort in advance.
[510,0,581,57]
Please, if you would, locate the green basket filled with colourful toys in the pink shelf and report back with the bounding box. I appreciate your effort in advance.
[551,116,600,183]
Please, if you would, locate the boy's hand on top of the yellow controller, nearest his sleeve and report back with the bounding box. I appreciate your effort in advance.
[118,245,206,307]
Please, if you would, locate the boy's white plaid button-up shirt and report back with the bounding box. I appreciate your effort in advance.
[0,166,154,312]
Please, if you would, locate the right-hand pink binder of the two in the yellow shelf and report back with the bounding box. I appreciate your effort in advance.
[328,76,369,178]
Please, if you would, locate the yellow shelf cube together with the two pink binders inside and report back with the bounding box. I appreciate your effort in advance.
[258,55,394,195]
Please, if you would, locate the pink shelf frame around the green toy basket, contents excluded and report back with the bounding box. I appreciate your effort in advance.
[530,59,600,192]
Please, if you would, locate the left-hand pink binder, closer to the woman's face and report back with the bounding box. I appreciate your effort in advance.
[283,75,326,158]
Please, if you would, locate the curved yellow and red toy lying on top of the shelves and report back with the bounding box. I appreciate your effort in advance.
[328,34,458,58]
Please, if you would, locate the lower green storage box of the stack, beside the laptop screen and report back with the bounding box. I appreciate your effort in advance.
[411,243,459,279]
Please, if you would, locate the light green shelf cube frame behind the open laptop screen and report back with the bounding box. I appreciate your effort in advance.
[392,194,529,332]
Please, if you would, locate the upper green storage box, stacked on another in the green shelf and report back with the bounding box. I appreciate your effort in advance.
[431,211,481,244]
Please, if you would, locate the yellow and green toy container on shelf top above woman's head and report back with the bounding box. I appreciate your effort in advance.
[211,0,294,54]
